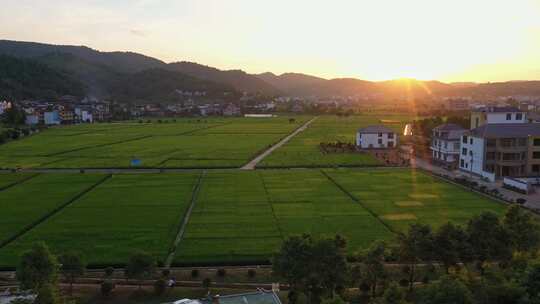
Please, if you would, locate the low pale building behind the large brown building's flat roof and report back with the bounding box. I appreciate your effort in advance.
[471,107,527,129]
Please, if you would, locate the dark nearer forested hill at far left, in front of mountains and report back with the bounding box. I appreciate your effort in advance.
[0,55,85,100]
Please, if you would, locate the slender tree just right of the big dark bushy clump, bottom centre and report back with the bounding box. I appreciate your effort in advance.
[359,242,386,297]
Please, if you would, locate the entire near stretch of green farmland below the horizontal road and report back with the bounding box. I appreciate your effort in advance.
[0,168,505,267]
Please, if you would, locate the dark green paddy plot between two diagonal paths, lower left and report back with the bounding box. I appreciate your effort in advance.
[0,173,198,266]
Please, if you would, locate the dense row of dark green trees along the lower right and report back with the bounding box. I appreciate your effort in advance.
[273,205,540,304]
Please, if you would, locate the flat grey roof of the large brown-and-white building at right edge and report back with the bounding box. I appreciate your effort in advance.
[469,123,540,138]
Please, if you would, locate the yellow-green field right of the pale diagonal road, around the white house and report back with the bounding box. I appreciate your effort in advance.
[258,114,415,168]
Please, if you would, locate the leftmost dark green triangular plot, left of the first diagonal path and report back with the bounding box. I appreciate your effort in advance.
[0,174,103,245]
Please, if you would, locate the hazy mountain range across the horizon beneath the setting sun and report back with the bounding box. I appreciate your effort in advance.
[0,40,540,101]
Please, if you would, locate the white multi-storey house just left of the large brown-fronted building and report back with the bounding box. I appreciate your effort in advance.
[430,124,467,169]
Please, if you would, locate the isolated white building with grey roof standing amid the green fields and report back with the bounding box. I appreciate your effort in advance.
[356,126,398,149]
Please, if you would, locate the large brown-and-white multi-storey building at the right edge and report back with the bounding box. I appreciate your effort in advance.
[459,123,540,180]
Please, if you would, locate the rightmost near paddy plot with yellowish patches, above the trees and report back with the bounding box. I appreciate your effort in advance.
[325,169,506,232]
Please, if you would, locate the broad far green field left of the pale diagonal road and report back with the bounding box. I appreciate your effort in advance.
[0,116,307,168]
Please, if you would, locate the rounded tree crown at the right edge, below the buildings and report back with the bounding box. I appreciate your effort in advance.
[503,205,540,252]
